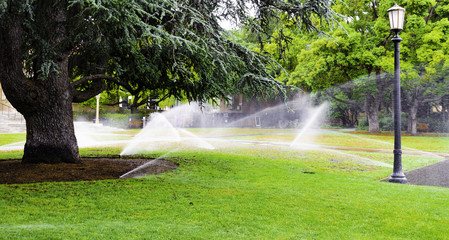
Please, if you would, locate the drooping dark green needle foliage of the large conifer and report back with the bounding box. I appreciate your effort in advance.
[0,0,337,102]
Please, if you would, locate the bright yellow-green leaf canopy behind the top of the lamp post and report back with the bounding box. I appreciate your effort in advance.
[266,0,448,90]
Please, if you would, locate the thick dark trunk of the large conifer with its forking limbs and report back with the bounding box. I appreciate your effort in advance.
[0,1,80,163]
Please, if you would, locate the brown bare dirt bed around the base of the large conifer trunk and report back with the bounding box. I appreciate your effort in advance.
[0,158,178,184]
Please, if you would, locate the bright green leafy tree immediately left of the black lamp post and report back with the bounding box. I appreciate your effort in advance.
[289,22,391,132]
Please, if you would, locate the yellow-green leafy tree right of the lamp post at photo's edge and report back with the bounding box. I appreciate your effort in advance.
[401,1,449,135]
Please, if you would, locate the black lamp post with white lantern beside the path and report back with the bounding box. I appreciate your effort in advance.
[388,4,407,183]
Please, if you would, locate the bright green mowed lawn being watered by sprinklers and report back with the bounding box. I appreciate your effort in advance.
[0,130,449,239]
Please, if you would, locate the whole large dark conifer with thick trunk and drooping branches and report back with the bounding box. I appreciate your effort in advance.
[0,0,342,163]
